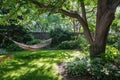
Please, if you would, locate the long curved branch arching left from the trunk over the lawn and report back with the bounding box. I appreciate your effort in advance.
[29,0,93,44]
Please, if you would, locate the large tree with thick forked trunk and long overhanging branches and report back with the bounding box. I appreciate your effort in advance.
[0,0,120,56]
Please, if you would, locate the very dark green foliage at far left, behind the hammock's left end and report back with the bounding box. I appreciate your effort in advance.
[0,24,33,48]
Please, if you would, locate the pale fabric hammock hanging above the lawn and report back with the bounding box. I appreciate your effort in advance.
[12,38,52,51]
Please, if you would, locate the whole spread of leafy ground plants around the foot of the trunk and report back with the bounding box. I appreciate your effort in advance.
[66,49,120,80]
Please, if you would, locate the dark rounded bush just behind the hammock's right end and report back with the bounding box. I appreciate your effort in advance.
[50,27,72,45]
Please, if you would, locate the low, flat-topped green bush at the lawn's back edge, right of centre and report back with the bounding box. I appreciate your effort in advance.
[57,41,79,49]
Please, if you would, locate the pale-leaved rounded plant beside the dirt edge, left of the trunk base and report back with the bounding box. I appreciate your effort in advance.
[66,57,88,77]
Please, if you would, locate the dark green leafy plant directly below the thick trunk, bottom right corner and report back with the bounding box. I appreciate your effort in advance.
[89,58,120,80]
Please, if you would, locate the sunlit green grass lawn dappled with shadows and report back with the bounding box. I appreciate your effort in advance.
[0,50,81,80]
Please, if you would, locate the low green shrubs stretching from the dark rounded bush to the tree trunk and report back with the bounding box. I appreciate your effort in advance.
[57,35,88,51]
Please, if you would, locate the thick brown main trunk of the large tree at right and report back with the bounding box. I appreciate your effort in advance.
[90,0,120,56]
